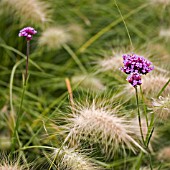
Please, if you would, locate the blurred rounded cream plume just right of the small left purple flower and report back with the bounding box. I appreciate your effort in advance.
[39,27,71,50]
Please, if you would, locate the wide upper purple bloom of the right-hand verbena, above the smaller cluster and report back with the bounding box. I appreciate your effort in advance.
[120,54,154,74]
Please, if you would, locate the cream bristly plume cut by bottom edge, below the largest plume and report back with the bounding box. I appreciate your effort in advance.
[54,147,99,170]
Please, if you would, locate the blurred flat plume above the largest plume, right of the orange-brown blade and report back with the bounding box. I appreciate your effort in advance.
[71,75,106,91]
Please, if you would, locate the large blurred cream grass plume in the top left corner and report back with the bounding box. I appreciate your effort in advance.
[1,0,51,26]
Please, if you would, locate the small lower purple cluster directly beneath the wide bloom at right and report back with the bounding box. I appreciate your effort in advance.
[126,73,142,87]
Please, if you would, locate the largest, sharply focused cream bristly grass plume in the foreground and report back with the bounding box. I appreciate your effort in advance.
[65,101,144,159]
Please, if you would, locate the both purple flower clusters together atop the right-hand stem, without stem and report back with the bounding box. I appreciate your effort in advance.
[120,54,154,87]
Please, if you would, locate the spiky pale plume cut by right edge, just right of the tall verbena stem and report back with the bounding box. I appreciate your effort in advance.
[152,95,170,120]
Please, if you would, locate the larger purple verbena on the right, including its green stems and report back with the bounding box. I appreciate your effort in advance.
[120,53,154,169]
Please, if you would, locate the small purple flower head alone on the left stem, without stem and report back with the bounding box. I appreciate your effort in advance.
[19,27,37,41]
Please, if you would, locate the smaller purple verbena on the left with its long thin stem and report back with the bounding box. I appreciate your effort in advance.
[12,27,37,152]
